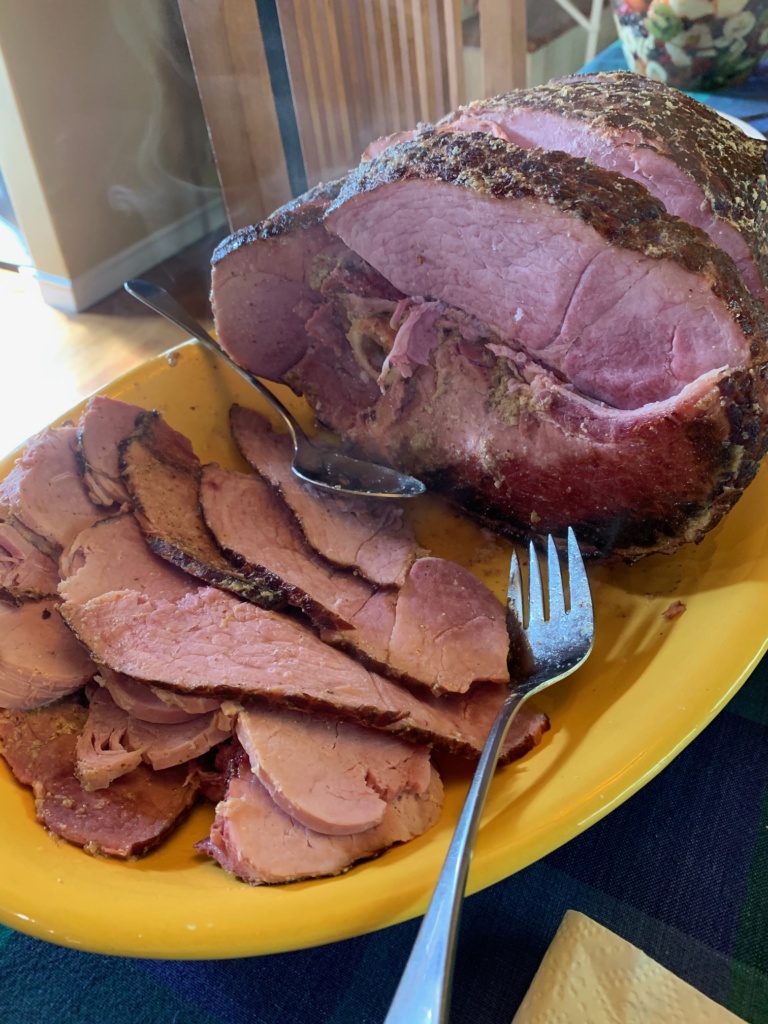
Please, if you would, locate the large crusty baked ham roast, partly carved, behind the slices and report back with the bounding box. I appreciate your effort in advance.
[213,76,768,560]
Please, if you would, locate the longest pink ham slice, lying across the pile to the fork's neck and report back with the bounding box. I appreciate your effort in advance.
[62,589,549,761]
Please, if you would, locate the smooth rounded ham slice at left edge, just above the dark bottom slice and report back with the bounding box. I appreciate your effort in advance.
[0,600,96,710]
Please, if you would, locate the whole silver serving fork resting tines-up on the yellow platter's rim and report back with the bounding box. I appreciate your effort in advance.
[385,527,594,1024]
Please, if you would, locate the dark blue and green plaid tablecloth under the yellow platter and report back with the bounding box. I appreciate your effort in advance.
[0,47,768,1024]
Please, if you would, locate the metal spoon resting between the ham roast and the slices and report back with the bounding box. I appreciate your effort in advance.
[124,279,426,498]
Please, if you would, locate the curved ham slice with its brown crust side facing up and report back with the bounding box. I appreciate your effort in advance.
[120,413,287,608]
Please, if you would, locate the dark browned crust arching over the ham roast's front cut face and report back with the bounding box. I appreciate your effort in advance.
[329,130,768,344]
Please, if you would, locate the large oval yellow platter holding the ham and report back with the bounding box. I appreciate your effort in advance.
[0,342,768,958]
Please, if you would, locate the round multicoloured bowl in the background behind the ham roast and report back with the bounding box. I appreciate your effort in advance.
[612,0,768,89]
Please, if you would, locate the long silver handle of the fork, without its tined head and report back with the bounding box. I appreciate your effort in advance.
[384,691,530,1024]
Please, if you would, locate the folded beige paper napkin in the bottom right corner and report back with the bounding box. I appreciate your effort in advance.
[512,910,744,1024]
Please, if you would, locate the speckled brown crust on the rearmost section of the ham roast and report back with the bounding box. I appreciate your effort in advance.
[462,72,768,282]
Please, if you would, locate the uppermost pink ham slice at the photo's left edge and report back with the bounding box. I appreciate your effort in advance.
[0,427,104,557]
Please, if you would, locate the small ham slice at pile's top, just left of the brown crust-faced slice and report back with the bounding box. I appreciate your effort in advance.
[77,395,145,509]
